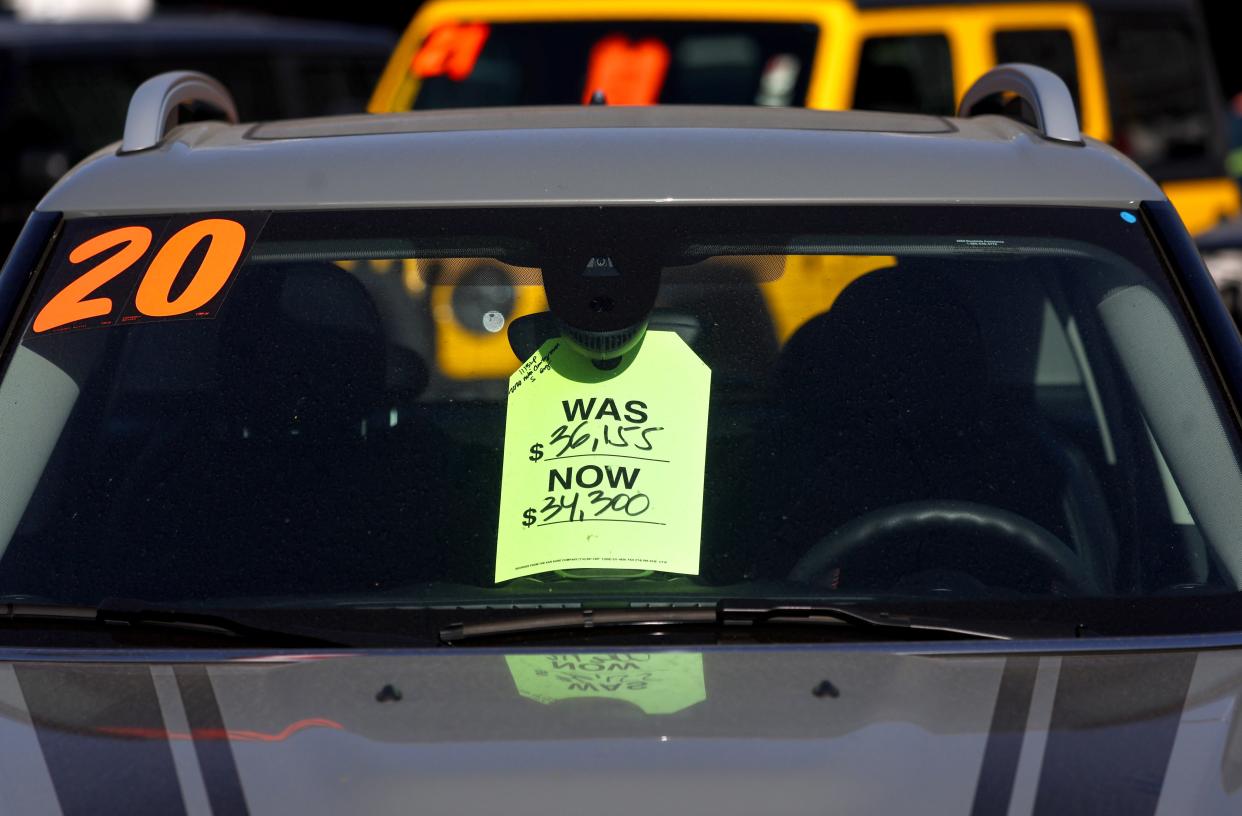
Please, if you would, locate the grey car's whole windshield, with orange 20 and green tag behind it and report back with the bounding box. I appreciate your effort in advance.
[0,206,1242,623]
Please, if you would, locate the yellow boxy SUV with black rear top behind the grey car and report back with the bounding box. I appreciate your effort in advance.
[369,0,1240,233]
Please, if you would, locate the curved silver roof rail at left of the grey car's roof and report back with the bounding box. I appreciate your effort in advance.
[118,71,237,153]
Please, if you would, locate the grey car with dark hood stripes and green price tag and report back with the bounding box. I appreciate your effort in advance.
[0,65,1242,815]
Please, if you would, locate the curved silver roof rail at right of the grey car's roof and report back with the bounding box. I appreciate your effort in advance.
[958,62,1083,144]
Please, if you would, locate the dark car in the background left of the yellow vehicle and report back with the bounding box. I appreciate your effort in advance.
[0,15,395,251]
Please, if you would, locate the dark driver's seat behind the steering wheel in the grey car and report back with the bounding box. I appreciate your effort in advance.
[760,260,1108,596]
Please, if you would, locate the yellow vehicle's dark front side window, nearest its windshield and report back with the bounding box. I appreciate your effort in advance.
[853,35,954,116]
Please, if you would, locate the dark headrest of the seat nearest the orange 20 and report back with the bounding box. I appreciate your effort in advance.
[220,262,386,435]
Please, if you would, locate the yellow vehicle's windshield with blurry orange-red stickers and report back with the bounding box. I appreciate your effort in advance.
[405,21,818,108]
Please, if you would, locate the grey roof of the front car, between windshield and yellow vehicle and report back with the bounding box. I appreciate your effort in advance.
[39,106,1164,215]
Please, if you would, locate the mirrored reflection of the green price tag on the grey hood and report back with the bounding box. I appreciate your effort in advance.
[504,652,707,714]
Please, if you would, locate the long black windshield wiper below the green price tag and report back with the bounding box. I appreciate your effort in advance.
[440,600,1016,643]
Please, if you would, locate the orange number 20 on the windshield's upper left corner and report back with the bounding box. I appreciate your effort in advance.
[32,219,246,333]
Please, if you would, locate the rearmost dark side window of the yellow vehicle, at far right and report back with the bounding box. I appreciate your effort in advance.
[1097,11,1223,181]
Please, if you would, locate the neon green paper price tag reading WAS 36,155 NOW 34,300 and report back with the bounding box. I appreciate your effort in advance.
[496,332,712,583]
